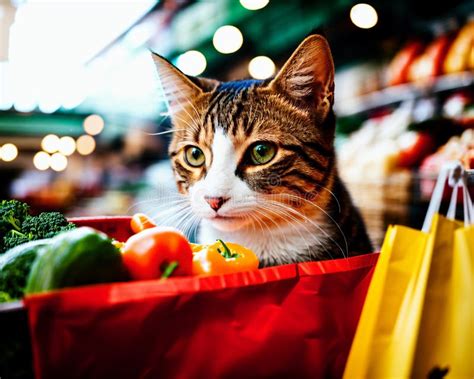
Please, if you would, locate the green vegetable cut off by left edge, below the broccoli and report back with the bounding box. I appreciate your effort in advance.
[0,240,49,303]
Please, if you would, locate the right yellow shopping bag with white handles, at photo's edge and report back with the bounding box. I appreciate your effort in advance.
[411,167,474,378]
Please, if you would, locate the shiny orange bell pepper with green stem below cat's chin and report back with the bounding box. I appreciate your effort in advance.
[193,240,259,275]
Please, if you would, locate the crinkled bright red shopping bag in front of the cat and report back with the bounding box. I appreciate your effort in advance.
[25,218,378,379]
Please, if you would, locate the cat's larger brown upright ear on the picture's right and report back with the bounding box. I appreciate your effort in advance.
[270,35,334,119]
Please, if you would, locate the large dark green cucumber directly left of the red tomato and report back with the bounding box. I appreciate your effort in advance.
[25,227,128,294]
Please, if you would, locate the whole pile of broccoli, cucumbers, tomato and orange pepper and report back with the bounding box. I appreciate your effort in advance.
[0,205,259,302]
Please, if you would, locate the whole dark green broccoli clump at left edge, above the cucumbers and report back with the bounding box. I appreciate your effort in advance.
[0,200,75,254]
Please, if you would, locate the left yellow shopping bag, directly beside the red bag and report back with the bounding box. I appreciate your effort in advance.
[344,226,431,379]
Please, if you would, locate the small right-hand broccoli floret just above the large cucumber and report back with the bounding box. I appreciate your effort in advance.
[21,212,76,239]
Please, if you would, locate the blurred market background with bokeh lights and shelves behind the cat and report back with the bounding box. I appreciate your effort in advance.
[0,0,474,244]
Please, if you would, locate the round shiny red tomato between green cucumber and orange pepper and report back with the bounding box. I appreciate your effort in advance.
[122,226,193,280]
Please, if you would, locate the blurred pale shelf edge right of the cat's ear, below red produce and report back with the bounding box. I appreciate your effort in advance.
[334,72,474,117]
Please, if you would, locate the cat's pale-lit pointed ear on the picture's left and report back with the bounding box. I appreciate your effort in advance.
[151,53,218,111]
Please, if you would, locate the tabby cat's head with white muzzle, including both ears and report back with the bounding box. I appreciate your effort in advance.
[154,36,334,235]
